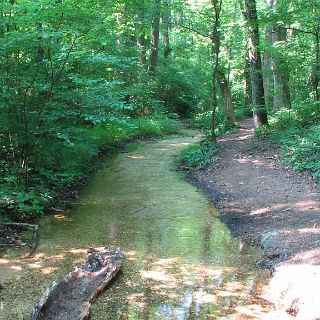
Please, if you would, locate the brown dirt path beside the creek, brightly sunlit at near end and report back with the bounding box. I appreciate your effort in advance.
[189,119,320,320]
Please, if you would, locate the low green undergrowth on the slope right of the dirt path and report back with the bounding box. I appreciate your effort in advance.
[255,111,320,181]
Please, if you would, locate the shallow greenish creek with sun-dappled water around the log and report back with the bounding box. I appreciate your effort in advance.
[0,132,270,320]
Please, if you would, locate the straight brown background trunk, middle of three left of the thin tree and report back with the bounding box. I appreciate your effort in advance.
[149,0,161,74]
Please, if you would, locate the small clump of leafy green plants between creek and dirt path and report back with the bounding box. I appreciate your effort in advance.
[180,140,218,170]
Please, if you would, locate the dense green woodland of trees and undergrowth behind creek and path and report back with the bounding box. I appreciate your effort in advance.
[0,0,320,222]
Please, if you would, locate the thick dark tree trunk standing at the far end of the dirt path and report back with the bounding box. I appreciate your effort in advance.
[244,0,268,128]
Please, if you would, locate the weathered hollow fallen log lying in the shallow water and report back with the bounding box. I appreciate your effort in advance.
[31,248,124,320]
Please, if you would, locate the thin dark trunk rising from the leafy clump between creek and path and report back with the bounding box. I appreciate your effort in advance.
[211,0,222,142]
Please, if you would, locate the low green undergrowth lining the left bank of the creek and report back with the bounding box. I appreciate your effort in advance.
[0,117,179,222]
